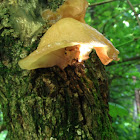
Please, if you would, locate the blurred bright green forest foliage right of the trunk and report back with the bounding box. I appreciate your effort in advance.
[86,0,140,140]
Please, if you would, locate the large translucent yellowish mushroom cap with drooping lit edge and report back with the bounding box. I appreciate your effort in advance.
[19,18,119,70]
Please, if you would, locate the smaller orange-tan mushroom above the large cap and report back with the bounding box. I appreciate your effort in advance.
[42,0,88,24]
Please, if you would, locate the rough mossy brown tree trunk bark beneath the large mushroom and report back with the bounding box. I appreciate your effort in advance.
[0,1,117,140]
